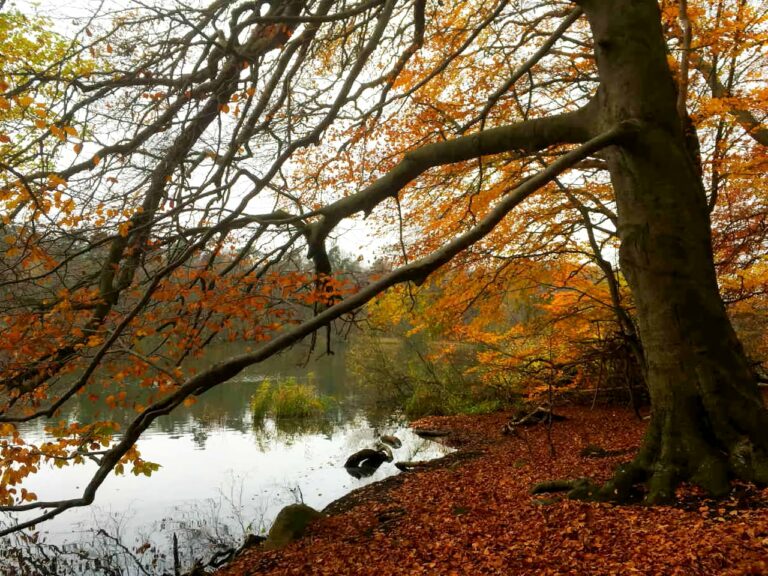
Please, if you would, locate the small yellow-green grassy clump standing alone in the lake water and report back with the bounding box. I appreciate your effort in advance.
[251,378,333,420]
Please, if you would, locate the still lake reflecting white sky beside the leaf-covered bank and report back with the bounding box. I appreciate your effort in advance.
[0,346,451,574]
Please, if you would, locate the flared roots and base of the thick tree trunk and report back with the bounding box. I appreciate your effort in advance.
[533,394,768,505]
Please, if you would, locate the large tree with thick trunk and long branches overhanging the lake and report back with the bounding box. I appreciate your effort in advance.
[0,0,768,530]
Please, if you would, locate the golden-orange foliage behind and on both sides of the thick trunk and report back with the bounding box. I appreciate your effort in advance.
[336,2,768,410]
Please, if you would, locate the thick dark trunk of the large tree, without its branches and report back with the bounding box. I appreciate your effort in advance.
[580,0,768,502]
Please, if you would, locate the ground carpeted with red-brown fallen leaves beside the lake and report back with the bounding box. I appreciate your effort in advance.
[217,407,768,576]
